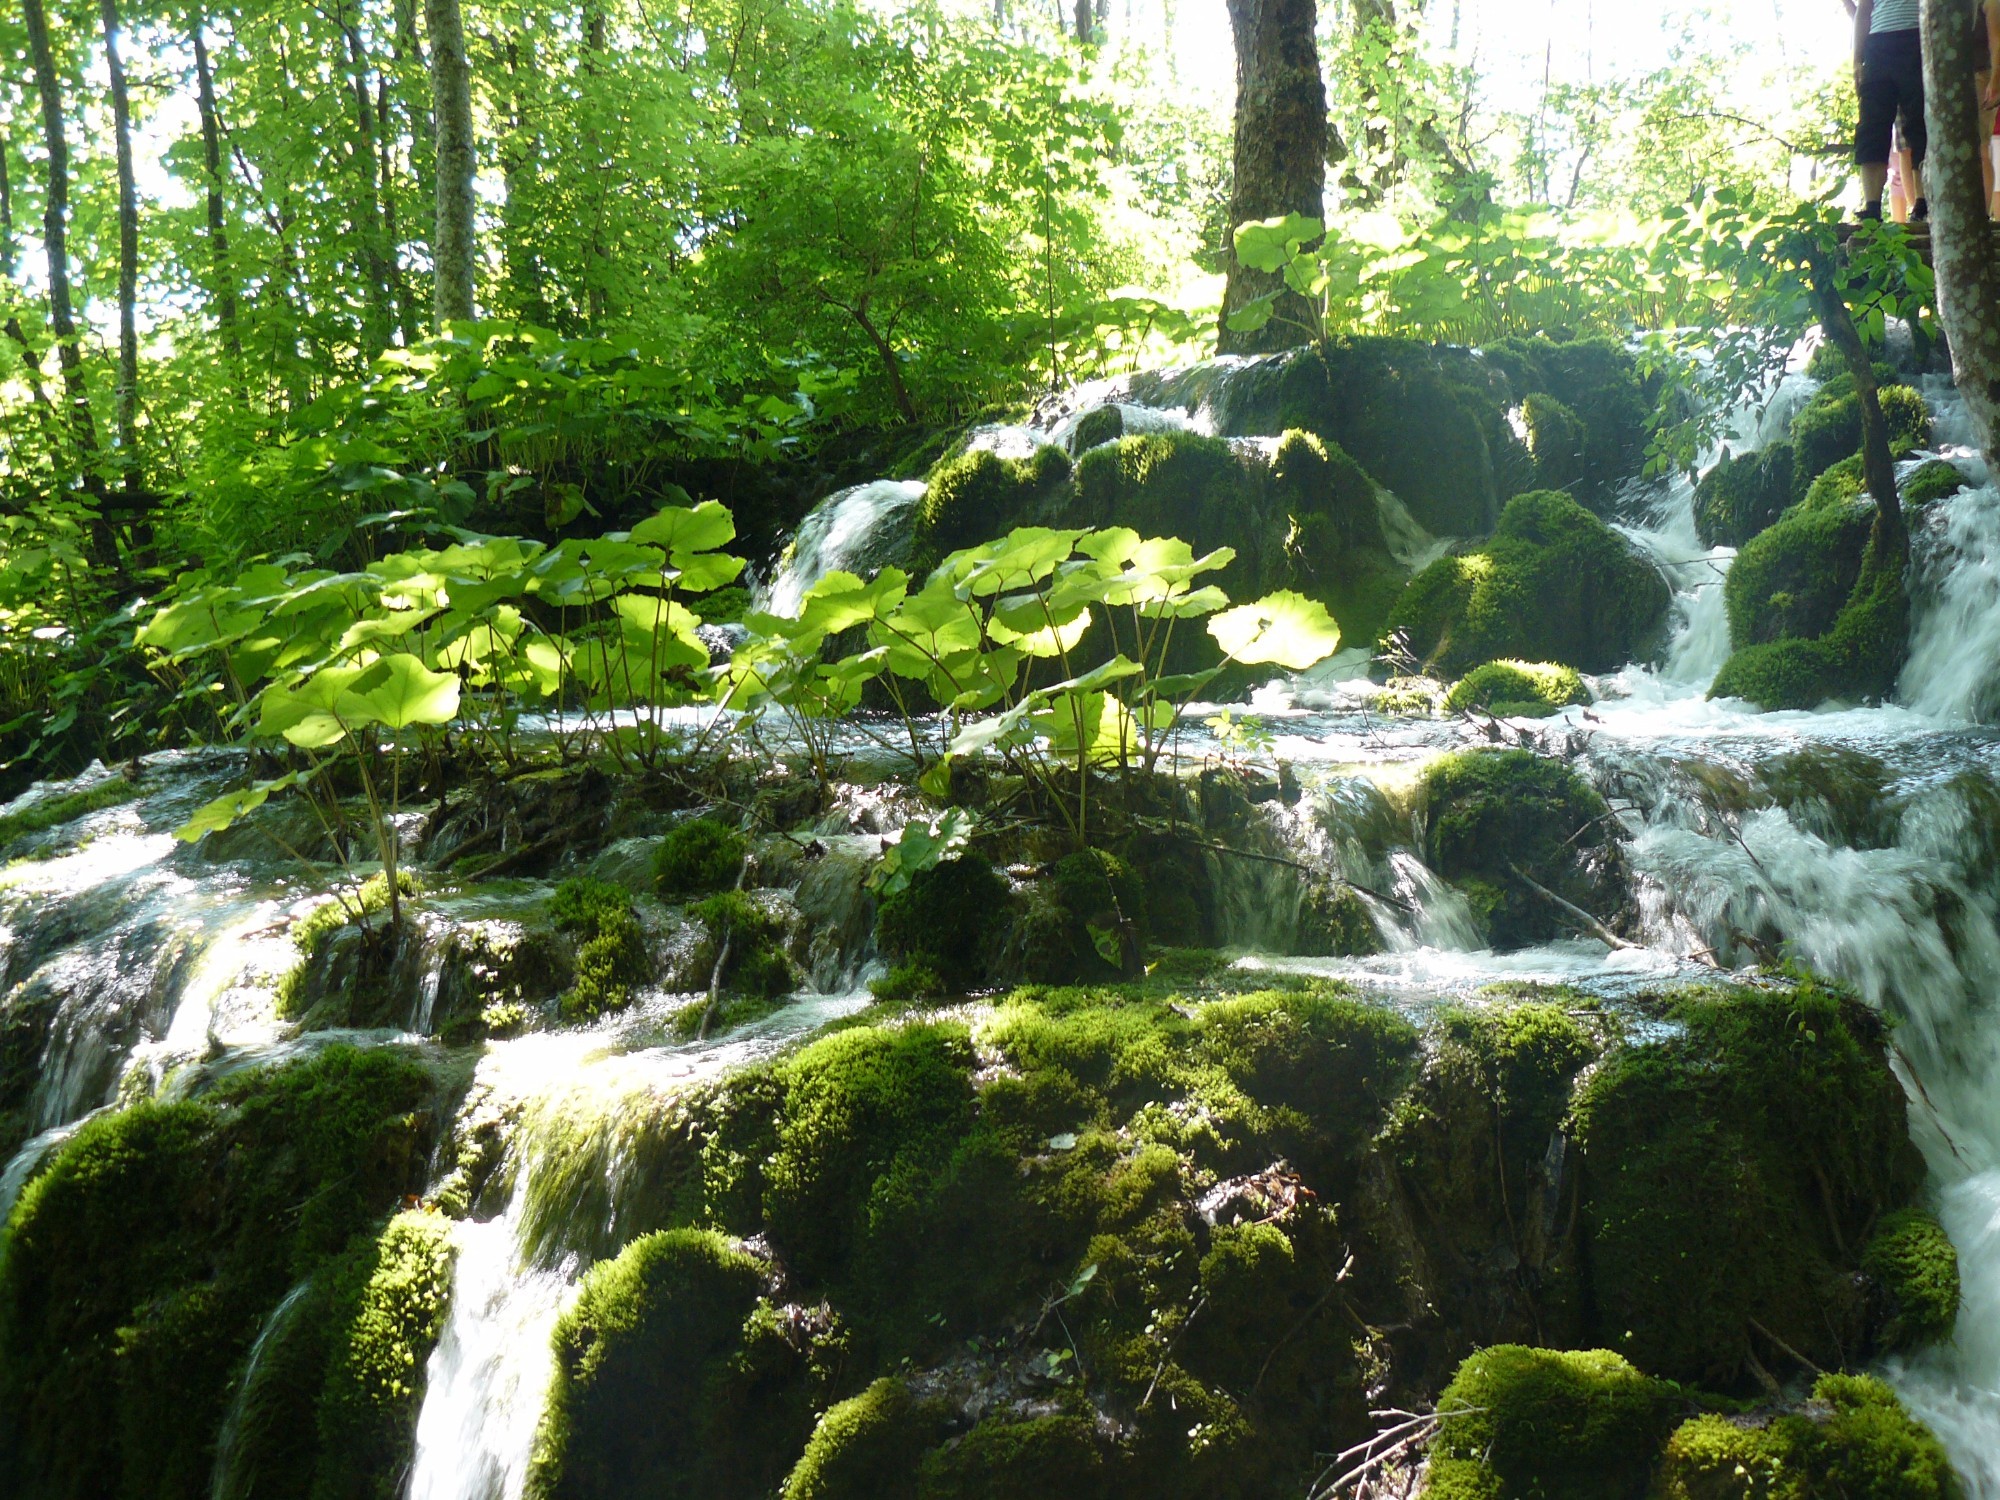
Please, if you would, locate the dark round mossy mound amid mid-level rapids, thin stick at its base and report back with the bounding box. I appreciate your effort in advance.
[1418,750,1626,948]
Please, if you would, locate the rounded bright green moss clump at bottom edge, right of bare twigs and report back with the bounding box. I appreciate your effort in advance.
[1426,1344,1672,1500]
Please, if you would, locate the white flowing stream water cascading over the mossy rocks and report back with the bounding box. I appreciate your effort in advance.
[11,362,2000,1500]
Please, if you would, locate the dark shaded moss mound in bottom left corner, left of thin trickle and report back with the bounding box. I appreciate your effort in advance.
[0,1048,436,1500]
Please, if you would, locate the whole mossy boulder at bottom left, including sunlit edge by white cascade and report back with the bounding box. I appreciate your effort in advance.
[0,1048,448,1500]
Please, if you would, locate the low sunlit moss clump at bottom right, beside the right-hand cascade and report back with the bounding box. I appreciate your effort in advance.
[1654,1374,1962,1500]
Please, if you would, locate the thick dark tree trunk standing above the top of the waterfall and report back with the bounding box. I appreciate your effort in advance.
[1216,0,1326,354]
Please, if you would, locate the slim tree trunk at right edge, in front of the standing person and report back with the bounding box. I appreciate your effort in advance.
[1922,0,2000,474]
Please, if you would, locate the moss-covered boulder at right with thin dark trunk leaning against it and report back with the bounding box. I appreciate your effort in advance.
[1710,458,1910,708]
